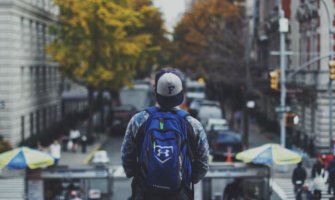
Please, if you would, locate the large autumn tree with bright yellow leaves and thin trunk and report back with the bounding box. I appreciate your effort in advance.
[48,0,167,134]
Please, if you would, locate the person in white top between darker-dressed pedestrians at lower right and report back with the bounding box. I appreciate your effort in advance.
[312,157,325,199]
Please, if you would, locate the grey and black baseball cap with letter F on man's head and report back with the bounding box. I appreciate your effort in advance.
[155,69,184,108]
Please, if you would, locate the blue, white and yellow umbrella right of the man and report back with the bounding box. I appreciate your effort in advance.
[236,144,302,165]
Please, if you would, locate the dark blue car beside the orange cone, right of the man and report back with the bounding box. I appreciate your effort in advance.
[209,130,243,161]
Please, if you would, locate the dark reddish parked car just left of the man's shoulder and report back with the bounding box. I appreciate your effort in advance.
[111,105,137,134]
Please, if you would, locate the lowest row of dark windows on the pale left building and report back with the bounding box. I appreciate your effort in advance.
[21,105,59,140]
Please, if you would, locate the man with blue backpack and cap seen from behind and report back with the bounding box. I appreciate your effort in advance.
[121,68,209,200]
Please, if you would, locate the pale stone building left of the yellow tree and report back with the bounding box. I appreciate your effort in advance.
[0,0,61,145]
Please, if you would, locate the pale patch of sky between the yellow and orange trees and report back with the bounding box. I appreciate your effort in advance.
[153,0,186,32]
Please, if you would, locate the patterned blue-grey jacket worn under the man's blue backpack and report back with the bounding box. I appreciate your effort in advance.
[121,111,209,200]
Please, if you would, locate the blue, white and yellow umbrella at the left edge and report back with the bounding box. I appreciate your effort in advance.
[0,147,54,169]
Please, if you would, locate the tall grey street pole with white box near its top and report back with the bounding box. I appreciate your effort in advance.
[278,1,288,147]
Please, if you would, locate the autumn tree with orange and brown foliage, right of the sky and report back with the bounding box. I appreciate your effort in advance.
[174,0,245,114]
